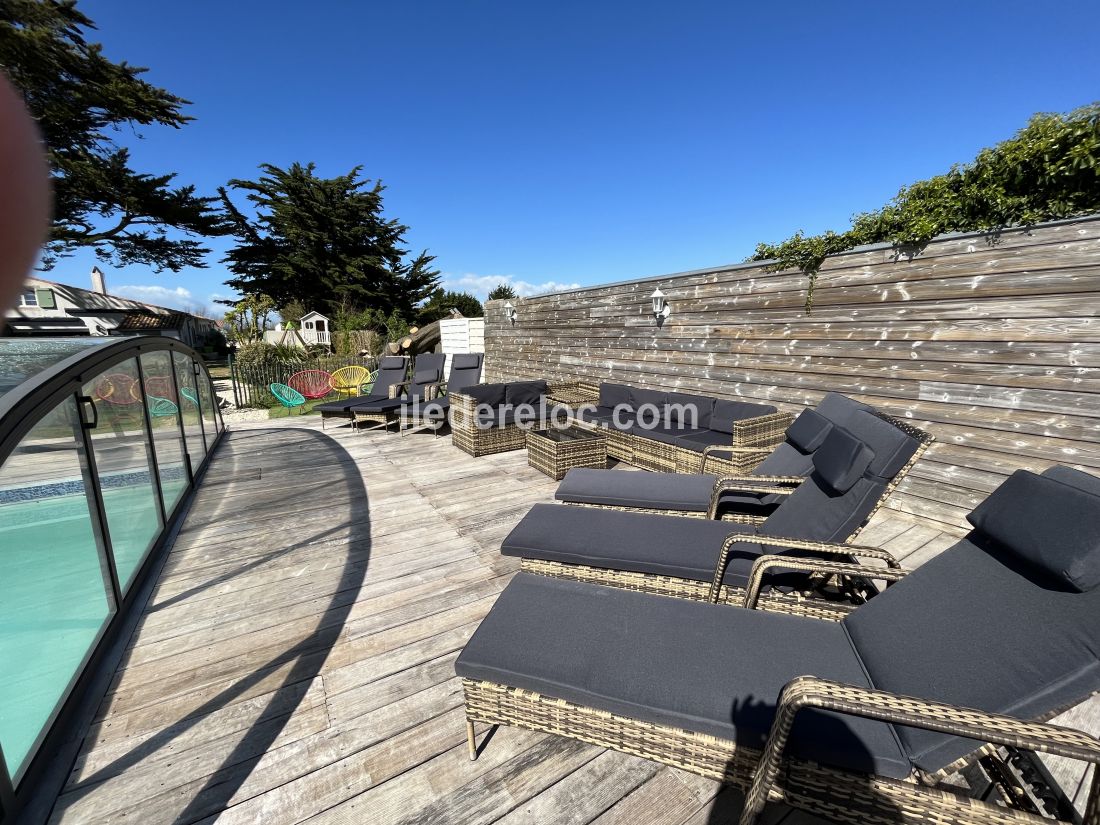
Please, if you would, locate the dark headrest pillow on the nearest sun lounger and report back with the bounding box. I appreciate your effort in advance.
[967,470,1100,593]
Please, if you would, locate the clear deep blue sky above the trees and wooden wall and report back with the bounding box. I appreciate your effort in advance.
[46,0,1100,314]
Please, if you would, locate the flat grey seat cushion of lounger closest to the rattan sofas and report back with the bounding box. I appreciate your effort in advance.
[554,468,714,513]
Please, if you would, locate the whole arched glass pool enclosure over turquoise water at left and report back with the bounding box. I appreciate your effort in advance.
[0,337,223,820]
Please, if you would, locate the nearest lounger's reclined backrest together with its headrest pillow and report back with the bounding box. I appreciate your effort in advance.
[844,468,1100,771]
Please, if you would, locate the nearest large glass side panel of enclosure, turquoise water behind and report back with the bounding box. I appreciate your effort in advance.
[0,397,112,778]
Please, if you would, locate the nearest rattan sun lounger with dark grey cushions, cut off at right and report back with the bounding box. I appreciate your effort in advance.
[455,469,1100,825]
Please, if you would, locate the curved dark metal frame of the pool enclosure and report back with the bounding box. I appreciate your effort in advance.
[0,336,224,823]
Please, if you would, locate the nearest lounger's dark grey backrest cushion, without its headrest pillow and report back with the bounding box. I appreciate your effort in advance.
[844,532,1100,771]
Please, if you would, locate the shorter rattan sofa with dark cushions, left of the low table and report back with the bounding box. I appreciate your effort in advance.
[449,381,593,457]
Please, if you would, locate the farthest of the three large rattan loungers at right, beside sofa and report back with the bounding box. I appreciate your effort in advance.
[554,393,873,524]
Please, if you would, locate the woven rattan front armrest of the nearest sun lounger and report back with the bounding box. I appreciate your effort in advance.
[740,677,1100,825]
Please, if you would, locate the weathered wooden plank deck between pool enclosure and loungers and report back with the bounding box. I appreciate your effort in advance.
[42,417,985,825]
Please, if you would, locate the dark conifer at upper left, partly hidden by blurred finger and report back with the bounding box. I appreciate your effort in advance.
[0,0,221,272]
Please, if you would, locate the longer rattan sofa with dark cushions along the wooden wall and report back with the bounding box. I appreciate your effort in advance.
[578,382,793,473]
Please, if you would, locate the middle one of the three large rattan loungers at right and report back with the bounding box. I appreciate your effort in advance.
[501,410,927,615]
